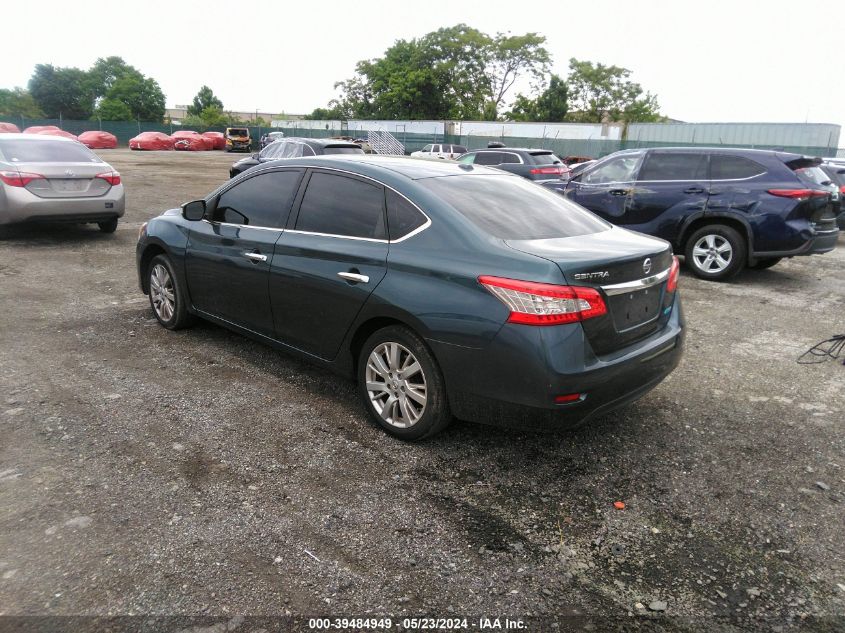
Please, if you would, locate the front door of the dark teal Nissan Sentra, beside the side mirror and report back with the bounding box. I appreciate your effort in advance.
[185,169,304,337]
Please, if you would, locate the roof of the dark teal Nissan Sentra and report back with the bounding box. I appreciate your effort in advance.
[254,154,518,180]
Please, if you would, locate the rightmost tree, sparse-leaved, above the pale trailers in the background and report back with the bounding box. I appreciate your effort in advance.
[567,57,663,123]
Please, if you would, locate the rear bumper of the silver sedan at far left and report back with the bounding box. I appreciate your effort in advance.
[0,185,126,225]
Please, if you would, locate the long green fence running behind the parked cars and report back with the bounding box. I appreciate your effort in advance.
[0,118,836,158]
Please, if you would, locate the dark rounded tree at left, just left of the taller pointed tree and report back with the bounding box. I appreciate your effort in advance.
[29,64,94,119]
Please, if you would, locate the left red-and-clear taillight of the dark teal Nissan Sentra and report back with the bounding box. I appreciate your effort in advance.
[478,275,607,325]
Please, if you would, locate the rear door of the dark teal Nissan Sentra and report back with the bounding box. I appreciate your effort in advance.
[270,170,388,359]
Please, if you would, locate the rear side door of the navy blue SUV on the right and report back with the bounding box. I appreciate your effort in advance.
[628,150,710,242]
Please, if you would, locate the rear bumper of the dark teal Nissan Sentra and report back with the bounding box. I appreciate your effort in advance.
[430,298,684,429]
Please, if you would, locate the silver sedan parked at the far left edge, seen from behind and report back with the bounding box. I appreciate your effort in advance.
[0,133,125,233]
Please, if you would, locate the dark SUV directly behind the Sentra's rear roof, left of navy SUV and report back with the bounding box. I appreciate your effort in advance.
[458,147,569,193]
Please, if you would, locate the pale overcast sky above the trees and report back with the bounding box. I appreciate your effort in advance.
[0,0,845,141]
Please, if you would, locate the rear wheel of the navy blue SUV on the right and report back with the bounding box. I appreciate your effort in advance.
[684,224,748,281]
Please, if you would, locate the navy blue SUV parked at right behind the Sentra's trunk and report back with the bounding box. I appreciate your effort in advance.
[566,147,839,281]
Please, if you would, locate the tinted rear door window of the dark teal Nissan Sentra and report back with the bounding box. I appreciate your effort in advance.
[296,172,386,239]
